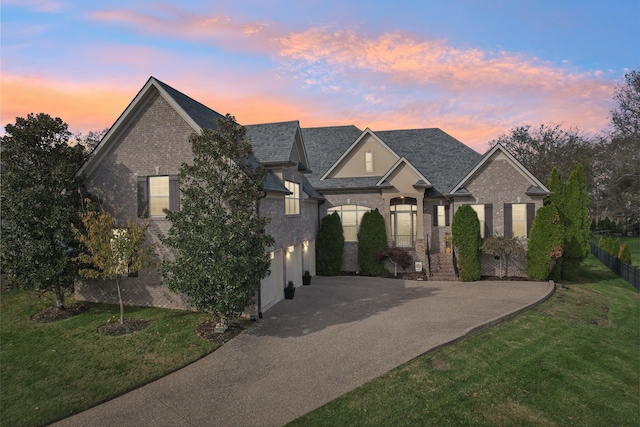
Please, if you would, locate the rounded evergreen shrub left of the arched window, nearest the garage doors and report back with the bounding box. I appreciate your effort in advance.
[316,212,344,276]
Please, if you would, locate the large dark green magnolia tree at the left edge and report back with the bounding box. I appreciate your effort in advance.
[0,113,85,309]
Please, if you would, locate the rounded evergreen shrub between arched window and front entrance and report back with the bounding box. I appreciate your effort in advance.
[358,209,387,276]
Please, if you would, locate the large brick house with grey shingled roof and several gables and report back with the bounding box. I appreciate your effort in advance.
[76,77,549,311]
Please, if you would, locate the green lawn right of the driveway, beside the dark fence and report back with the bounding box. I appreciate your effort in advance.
[290,257,640,426]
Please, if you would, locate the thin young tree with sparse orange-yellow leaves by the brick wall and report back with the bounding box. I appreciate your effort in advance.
[74,211,155,325]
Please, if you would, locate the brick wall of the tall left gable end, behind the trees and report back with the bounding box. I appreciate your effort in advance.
[75,92,194,309]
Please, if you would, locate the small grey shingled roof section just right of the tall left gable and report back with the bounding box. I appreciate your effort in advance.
[245,120,299,164]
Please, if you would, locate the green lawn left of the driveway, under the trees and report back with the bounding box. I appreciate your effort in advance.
[0,292,215,426]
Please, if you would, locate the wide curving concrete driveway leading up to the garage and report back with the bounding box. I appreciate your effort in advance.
[56,276,553,427]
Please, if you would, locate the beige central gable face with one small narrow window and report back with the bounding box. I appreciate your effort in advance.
[322,129,399,179]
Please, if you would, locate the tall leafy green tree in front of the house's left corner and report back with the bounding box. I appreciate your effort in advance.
[161,114,274,329]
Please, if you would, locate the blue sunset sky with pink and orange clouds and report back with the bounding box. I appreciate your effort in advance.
[0,0,640,152]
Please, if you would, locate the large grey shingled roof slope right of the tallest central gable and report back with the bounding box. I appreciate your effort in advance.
[374,128,482,194]
